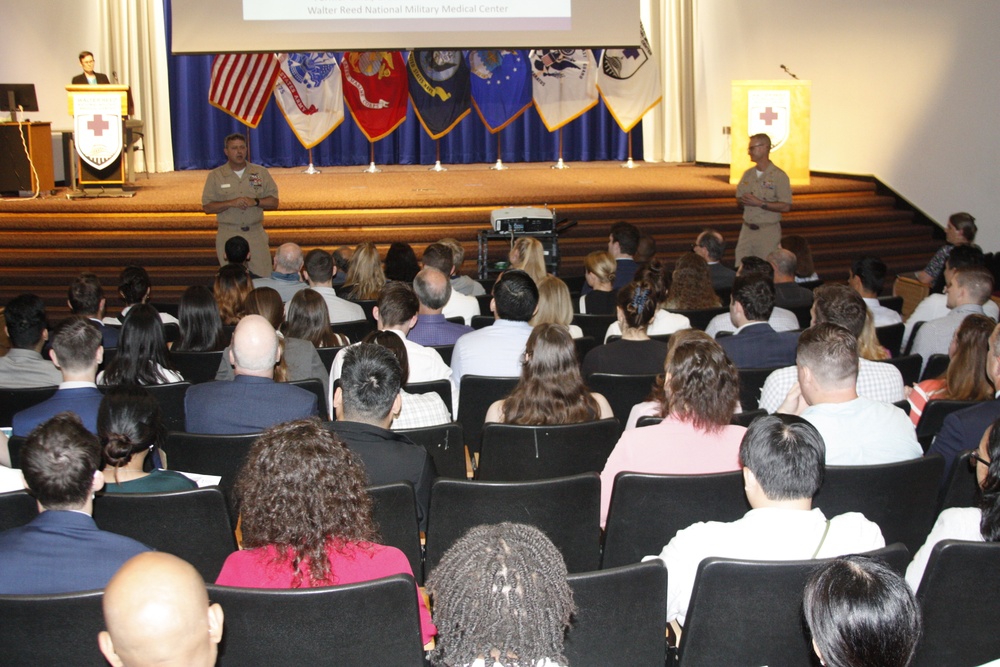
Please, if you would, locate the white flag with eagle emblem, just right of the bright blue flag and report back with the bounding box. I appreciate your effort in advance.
[528,49,597,132]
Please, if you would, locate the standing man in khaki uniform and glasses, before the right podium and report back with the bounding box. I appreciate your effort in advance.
[736,134,792,266]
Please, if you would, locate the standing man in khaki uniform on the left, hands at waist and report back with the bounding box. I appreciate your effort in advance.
[201,134,278,276]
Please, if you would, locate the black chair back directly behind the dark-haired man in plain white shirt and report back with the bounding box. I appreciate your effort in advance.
[677,544,912,667]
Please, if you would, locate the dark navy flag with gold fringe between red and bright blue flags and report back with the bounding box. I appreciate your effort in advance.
[406,49,472,139]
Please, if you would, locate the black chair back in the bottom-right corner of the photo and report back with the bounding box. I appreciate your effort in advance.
[913,540,1000,667]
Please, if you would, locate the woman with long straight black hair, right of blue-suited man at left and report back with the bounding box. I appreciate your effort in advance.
[97,303,184,385]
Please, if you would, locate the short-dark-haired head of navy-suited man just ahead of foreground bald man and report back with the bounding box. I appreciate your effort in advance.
[21,412,101,509]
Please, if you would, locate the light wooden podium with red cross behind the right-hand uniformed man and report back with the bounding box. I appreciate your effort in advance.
[729,79,812,185]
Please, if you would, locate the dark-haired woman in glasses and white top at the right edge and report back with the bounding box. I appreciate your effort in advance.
[906,419,1000,590]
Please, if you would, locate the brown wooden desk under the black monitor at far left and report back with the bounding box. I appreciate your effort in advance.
[0,123,56,192]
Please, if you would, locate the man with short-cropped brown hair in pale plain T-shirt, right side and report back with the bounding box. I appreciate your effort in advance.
[778,323,923,466]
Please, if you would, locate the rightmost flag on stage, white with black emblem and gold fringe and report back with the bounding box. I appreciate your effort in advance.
[597,23,662,132]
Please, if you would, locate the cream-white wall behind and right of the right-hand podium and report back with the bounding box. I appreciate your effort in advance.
[695,0,1000,251]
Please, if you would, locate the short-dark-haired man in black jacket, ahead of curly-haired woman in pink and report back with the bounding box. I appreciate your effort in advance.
[333,343,435,529]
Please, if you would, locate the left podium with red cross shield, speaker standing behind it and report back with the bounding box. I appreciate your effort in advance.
[66,85,128,187]
